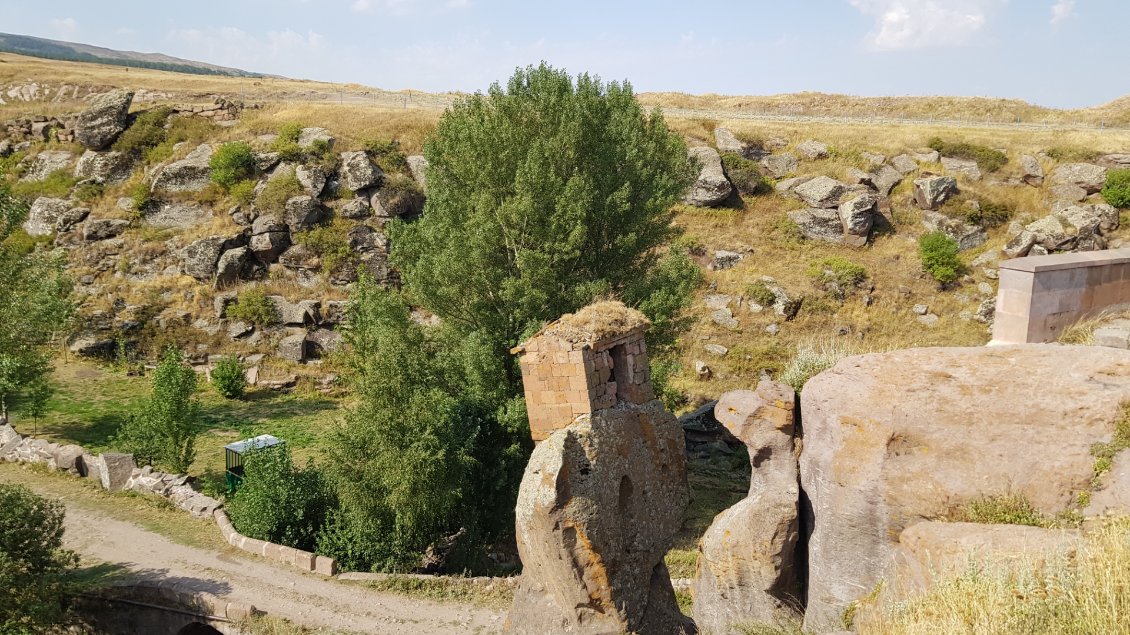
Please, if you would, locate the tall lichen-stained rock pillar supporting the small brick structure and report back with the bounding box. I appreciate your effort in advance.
[504,401,695,635]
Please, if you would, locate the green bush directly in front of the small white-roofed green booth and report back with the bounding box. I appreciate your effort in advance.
[225,444,334,551]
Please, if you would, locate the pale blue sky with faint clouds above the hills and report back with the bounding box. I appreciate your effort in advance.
[0,0,1130,107]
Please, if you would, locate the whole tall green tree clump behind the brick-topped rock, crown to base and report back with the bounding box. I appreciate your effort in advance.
[319,64,699,569]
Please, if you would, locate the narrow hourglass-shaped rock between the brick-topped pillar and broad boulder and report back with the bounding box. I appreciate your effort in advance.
[693,381,800,633]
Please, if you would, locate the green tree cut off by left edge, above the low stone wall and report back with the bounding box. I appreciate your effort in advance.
[0,182,75,419]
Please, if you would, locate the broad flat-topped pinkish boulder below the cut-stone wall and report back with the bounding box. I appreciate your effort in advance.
[800,345,1130,632]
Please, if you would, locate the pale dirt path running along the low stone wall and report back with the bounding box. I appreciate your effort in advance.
[0,476,505,635]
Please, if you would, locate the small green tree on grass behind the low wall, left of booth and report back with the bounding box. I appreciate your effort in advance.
[119,347,200,473]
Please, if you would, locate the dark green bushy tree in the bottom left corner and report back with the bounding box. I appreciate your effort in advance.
[0,484,78,635]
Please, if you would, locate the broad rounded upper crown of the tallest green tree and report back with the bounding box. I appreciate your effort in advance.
[391,63,694,368]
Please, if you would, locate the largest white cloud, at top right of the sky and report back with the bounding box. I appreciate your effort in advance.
[849,0,1007,51]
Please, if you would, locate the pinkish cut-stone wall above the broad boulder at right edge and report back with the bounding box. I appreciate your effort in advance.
[992,249,1130,343]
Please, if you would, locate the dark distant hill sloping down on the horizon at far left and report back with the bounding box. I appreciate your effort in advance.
[0,33,266,77]
